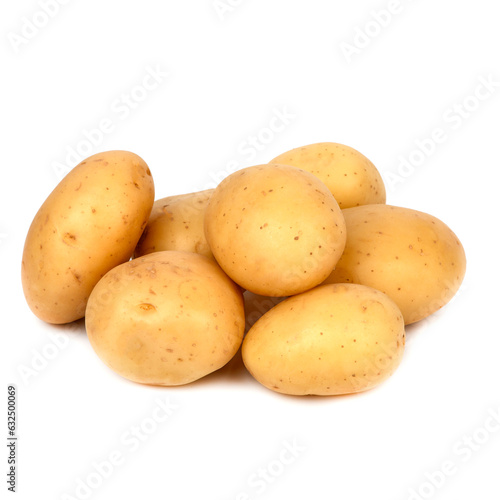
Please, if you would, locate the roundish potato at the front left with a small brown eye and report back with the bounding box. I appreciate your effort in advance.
[85,251,245,385]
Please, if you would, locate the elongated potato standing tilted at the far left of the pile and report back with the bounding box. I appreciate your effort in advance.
[21,151,154,324]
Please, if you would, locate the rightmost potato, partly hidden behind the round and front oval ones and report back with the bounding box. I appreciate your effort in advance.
[325,205,466,325]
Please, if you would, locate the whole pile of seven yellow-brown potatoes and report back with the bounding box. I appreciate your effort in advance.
[22,143,466,395]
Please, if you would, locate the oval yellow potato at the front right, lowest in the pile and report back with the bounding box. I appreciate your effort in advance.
[242,284,405,396]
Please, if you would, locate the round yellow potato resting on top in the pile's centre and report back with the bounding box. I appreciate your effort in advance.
[205,165,346,297]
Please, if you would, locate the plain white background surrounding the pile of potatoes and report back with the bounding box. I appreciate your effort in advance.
[0,0,500,500]
